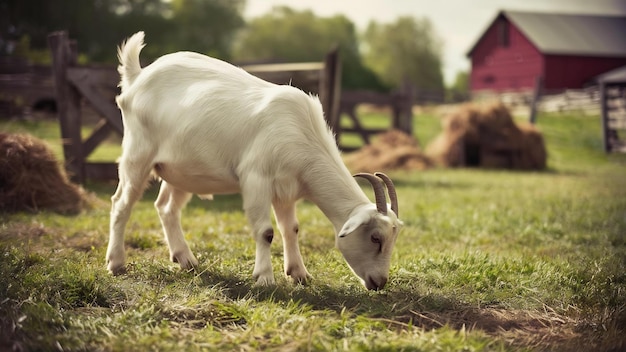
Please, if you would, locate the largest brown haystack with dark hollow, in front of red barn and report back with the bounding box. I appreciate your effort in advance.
[426,103,547,170]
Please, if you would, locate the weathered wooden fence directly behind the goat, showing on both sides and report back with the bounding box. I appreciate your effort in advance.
[48,31,341,183]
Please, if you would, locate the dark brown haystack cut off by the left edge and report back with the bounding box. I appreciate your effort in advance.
[0,133,88,214]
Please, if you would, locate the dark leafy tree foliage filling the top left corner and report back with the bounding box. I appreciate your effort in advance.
[0,0,169,62]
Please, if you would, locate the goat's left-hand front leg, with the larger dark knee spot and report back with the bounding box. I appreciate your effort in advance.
[241,176,275,286]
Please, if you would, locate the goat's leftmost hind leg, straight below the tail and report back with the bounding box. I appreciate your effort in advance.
[106,156,151,275]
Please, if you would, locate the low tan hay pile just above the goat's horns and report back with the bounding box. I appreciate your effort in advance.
[345,130,433,172]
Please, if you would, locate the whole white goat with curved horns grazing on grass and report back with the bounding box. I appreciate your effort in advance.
[106,32,402,289]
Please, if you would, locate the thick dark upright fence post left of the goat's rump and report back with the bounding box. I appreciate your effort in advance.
[48,31,85,183]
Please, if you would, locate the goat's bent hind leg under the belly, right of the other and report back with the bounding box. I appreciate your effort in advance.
[154,181,198,269]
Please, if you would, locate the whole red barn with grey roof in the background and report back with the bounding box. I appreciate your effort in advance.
[467,11,626,93]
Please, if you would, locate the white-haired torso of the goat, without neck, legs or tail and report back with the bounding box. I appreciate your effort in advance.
[112,52,339,193]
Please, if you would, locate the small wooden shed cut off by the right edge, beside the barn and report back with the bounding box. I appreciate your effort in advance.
[596,66,626,153]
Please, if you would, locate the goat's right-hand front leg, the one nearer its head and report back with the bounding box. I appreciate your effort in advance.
[273,202,311,283]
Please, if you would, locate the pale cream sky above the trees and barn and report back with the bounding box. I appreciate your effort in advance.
[244,0,626,84]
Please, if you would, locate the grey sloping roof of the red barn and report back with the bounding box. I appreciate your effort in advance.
[468,10,626,57]
